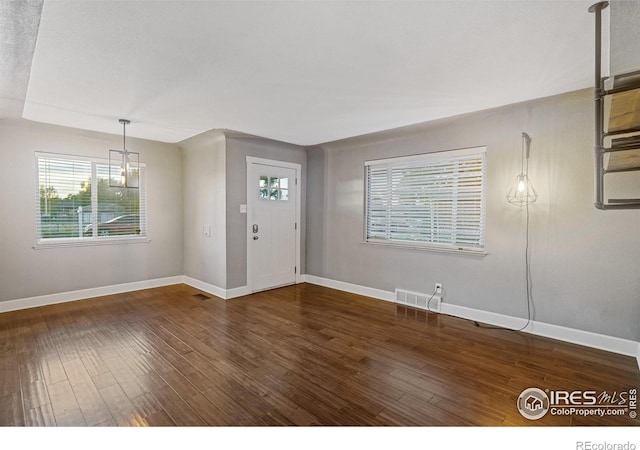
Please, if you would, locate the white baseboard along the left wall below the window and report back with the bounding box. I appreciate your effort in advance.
[0,275,183,313]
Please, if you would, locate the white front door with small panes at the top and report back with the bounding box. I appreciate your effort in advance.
[247,159,298,292]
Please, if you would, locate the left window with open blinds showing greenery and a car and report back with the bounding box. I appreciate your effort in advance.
[36,153,147,247]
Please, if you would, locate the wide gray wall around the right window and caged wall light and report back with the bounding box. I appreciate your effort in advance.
[307,89,640,341]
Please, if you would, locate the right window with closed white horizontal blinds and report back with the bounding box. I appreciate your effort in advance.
[365,147,486,253]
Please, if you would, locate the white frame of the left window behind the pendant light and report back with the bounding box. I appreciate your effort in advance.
[33,152,150,250]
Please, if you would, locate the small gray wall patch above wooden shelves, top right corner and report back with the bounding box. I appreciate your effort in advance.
[608,0,640,75]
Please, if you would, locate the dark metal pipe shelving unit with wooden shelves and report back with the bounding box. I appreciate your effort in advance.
[589,2,640,209]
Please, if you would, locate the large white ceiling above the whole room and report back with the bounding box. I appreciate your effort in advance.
[23,0,594,145]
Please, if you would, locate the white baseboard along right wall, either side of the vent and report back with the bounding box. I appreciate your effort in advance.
[304,275,640,358]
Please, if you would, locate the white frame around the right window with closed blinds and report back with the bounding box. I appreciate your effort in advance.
[363,146,487,256]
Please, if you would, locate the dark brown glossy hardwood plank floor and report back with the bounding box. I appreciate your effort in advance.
[0,284,640,426]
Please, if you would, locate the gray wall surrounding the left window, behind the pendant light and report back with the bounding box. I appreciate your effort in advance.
[0,119,183,301]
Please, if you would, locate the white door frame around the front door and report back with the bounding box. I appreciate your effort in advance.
[245,156,302,292]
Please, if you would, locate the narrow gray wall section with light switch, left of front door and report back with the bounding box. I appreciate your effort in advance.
[180,131,227,289]
